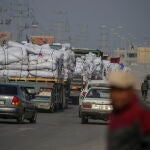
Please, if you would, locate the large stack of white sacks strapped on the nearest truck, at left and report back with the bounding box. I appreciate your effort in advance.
[0,41,75,78]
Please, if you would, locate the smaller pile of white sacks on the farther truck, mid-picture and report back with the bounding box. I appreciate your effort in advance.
[75,53,126,80]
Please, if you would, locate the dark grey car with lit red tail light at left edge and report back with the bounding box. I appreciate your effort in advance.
[0,83,37,123]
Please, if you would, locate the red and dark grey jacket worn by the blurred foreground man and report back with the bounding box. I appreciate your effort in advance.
[108,95,150,150]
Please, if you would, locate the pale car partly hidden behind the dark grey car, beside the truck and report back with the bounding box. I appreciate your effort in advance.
[32,95,55,112]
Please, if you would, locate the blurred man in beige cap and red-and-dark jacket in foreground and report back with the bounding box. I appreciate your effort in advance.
[108,71,150,150]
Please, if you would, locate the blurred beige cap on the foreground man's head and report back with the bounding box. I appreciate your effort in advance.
[108,70,136,88]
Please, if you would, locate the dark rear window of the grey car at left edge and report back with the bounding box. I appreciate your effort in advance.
[0,85,17,95]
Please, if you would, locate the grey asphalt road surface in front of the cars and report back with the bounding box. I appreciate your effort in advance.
[0,106,107,150]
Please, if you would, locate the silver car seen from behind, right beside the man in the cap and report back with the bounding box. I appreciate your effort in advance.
[80,87,112,124]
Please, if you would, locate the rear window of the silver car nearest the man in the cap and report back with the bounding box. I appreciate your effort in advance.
[86,89,110,99]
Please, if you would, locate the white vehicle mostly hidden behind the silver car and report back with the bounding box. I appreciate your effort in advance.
[79,80,109,117]
